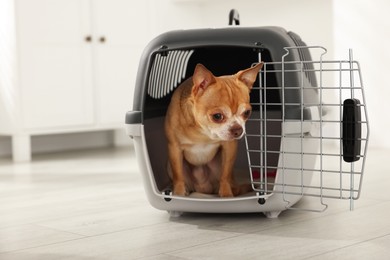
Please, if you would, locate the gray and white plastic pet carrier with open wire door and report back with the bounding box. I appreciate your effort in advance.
[126,27,369,217]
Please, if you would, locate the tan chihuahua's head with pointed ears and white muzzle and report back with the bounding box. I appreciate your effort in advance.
[191,63,263,141]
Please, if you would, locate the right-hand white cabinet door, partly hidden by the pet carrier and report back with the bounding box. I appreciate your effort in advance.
[92,0,149,127]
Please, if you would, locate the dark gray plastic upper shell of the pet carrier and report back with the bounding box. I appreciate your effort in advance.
[126,27,317,124]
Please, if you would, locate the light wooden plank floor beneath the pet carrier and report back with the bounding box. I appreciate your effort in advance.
[0,145,390,260]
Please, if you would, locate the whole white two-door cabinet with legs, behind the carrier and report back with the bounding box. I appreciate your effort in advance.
[0,0,150,161]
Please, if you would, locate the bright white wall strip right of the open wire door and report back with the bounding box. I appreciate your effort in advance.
[333,0,390,148]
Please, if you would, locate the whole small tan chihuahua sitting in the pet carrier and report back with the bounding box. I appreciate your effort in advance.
[165,63,263,197]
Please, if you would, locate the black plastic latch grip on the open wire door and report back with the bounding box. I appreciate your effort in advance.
[342,98,362,162]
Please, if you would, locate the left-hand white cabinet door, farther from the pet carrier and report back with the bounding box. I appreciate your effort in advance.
[16,0,93,128]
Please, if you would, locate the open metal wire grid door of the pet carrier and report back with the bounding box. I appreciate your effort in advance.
[245,47,369,210]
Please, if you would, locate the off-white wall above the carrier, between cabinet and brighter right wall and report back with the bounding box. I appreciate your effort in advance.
[163,0,333,54]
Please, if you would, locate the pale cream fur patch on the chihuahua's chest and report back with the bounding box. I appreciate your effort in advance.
[184,143,220,166]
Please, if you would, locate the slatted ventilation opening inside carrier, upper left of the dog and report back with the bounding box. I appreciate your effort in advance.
[148,50,194,99]
